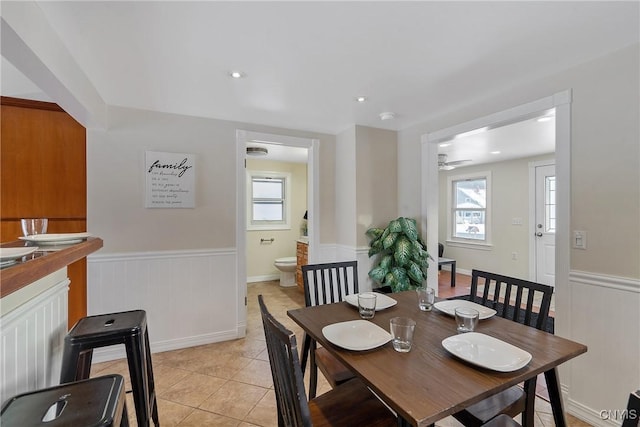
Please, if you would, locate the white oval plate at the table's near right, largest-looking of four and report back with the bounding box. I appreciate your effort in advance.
[442,332,531,372]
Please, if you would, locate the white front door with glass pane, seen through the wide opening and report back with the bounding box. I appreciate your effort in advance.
[534,165,556,286]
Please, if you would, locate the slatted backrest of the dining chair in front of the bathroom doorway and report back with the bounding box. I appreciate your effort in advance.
[302,261,359,307]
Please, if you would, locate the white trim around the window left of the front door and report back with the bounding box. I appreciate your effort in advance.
[447,171,493,250]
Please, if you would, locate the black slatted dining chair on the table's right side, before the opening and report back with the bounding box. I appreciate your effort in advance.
[453,270,561,427]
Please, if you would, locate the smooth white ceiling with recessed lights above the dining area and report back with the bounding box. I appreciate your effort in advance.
[2,1,640,165]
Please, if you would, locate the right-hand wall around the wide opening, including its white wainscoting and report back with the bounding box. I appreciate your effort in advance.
[398,44,640,425]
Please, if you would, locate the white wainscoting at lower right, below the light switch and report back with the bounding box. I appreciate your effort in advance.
[559,271,640,426]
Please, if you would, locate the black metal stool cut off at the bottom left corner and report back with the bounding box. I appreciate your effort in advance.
[0,375,129,427]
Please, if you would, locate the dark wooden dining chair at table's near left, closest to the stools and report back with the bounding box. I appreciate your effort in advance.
[258,295,398,427]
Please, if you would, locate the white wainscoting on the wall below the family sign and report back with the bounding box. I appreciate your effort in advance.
[87,249,240,362]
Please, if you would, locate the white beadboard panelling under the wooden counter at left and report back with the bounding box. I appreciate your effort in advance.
[0,278,69,402]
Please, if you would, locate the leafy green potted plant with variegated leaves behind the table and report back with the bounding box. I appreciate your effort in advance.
[367,217,431,292]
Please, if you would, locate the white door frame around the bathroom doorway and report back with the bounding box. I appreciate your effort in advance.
[236,129,320,337]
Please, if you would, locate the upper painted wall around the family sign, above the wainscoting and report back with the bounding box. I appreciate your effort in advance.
[87,108,334,253]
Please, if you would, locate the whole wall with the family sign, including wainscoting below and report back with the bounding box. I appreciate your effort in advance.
[87,108,335,360]
